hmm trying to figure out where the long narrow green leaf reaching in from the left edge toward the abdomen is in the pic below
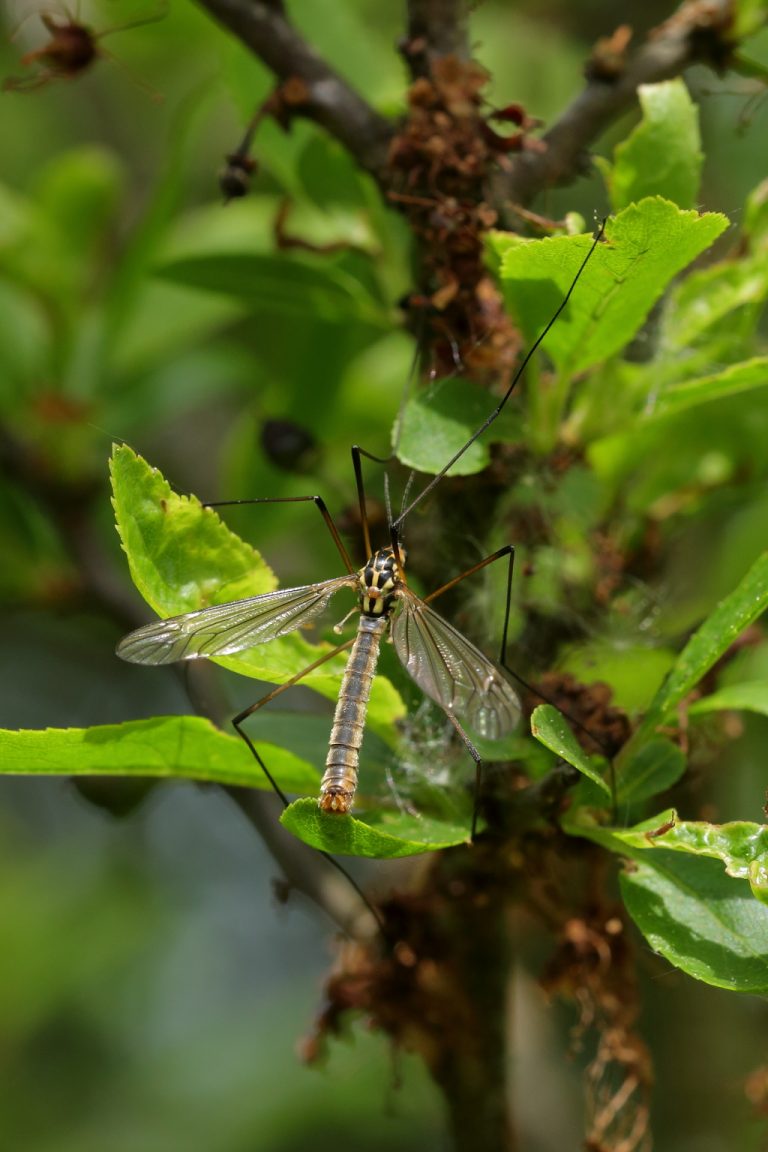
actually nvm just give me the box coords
[0,717,319,793]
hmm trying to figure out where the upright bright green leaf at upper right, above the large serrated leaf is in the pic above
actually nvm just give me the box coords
[608,79,704,210]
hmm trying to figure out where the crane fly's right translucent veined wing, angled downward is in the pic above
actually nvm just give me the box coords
[390,589,520,740]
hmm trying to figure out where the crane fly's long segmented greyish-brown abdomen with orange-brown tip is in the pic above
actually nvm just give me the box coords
[318,616,388,813]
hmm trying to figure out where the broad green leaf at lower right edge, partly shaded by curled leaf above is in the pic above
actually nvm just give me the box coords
[621,851,768,995]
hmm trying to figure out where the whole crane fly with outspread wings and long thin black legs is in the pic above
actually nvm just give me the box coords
[117,227,602,835]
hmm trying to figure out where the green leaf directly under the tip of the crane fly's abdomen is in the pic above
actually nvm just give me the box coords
[280,799,470,859]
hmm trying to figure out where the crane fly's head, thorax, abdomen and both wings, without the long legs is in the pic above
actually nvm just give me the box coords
[117,546,520,813]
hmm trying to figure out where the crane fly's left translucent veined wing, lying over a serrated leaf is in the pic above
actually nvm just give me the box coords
[117,576,357,664]
